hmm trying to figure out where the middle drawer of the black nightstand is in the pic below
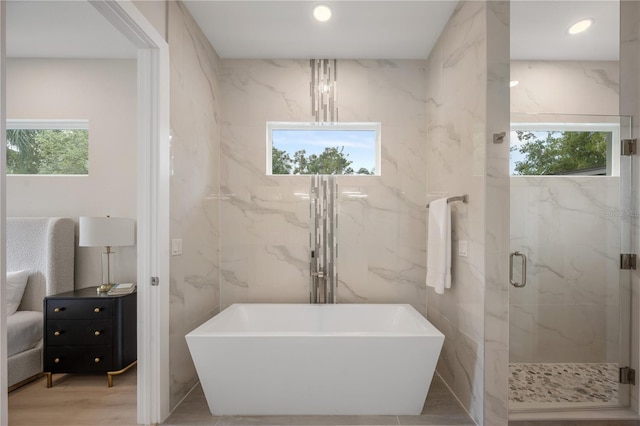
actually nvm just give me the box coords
[46,320,113,346]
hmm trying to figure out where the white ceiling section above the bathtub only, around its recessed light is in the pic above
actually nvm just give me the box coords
[185,0,457,59]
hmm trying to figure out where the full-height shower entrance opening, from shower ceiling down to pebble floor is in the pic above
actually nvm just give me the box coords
[509,2,633,414]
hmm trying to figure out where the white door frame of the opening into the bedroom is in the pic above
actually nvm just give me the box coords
[0,0,170,425]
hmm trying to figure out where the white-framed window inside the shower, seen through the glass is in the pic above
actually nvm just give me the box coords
[509,123,620,176]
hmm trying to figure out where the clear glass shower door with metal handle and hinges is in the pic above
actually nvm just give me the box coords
[509,114,636,411]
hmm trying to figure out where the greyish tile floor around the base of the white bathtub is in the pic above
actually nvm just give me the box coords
[163,376,475,426]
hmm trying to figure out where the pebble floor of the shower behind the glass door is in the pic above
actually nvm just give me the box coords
[509,363,618,404]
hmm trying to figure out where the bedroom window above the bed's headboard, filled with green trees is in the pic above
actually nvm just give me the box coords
[7,120,89,175]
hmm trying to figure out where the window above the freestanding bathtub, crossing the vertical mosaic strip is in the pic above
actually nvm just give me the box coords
[267,122,380,176]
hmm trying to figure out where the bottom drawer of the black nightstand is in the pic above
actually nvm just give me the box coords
[43,346,112,373]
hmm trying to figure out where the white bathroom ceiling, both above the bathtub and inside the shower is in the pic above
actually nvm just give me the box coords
[185,0,620,60]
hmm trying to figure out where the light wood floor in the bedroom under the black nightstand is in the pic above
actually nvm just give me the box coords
[9,367,137,426]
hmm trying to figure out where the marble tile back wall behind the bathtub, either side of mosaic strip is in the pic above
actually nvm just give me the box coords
[220,60,426,312]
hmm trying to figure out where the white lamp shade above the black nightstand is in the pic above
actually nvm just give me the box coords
[79,217,134,247]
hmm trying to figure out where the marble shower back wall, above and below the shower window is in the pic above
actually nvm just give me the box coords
[509,61,621,362]
